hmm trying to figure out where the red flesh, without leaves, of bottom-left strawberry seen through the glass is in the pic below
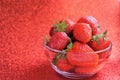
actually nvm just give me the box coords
[57,59,74,71]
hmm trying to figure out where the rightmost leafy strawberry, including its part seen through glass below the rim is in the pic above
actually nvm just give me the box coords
[88,32,110,59]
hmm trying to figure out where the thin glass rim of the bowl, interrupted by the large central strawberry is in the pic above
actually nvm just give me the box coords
[44,42,112,54]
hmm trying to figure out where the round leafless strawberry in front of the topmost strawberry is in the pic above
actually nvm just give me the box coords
[73,23,92,43]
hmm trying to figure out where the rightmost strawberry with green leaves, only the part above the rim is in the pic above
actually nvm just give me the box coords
[89,32,110,51]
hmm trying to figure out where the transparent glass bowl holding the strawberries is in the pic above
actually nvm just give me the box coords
[44,43,112,79]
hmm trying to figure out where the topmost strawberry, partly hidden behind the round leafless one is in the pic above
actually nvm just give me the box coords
[78,16,100,35]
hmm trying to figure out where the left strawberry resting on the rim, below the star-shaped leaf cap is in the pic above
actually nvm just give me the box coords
[47,32,69,50]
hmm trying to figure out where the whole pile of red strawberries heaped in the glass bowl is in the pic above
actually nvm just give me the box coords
[46,16,110,74]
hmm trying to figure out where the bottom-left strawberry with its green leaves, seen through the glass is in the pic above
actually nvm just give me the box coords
[53,53,74,71]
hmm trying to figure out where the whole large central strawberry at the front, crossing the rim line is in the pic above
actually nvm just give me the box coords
[67,42,98,67]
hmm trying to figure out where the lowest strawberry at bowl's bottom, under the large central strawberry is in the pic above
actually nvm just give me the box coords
[74,66,97,74]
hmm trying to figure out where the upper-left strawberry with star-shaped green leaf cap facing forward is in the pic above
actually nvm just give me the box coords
[49,19,75,36]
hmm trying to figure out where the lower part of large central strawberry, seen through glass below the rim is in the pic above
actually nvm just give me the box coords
[67,51,99,67]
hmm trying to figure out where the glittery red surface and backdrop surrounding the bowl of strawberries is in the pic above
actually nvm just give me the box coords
[0,0,120,80]
